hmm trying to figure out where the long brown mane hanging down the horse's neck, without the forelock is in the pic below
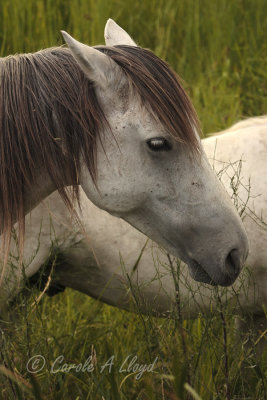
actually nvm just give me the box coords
[0,48,106,264]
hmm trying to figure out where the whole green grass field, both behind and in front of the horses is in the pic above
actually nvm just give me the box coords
[0,0,267,400]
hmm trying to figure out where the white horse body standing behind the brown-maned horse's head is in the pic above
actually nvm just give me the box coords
[2,116,267,334]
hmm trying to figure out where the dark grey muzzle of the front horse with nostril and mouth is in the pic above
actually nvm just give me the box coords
[172,196,248,286]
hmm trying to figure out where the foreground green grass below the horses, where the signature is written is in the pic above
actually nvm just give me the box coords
[0,268,267,400]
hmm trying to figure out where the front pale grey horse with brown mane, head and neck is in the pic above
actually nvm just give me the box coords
[0,21,248,286]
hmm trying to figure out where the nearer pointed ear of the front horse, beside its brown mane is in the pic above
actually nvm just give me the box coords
[61,31,121,88]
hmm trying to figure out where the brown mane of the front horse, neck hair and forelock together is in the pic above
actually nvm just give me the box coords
[0,46,199,266]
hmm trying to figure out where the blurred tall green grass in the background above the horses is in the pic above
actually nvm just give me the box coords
[0,0,267,132]
